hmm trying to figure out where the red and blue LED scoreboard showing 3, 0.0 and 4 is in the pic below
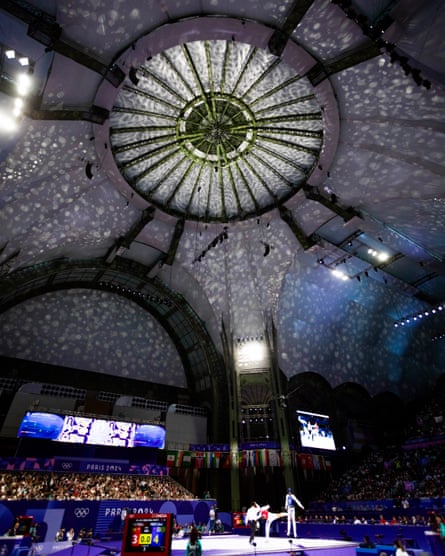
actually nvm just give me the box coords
[121,513,173,556]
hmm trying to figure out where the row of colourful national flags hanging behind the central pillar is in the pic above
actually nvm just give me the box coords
[167,449,331,471]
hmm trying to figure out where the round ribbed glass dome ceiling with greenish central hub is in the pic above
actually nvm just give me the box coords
[110,40,323,222]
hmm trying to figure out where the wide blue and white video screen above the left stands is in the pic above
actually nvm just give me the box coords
[17,411,165,449]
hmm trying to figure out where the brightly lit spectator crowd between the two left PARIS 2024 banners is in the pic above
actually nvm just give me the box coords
[0,471,195,500]
